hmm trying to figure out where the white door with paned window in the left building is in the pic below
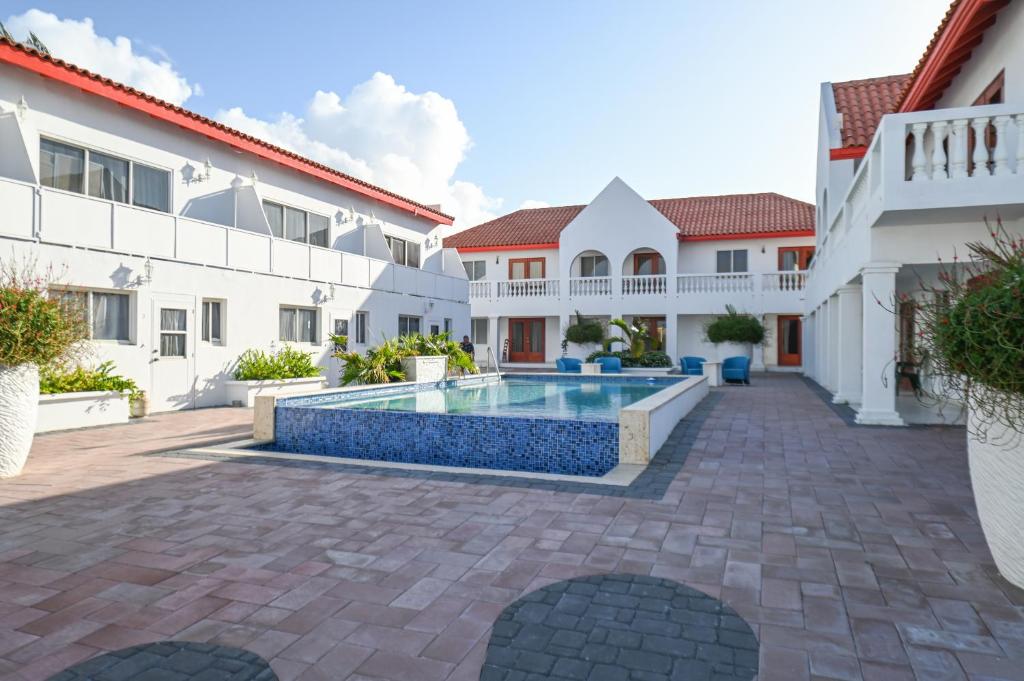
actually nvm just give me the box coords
[150,294,196,412]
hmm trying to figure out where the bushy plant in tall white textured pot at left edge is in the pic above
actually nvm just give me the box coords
[0,261,86,477]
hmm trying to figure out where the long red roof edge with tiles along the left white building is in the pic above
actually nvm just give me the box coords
[0,37,454,224]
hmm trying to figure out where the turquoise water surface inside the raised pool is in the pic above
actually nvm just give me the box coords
[315,378,667,422]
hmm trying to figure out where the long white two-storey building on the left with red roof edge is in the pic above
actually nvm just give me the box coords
[0,39,470,411]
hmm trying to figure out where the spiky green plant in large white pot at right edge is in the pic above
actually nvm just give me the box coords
[900,221,1024,588]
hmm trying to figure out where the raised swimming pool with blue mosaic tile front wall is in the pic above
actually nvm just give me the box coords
[255,374,707,476]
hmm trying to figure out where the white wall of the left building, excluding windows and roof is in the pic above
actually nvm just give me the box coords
[0,65,470,411]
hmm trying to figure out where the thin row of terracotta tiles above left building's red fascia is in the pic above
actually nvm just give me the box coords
[0,37,453,223]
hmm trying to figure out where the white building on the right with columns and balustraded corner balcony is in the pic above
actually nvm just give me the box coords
[804,0,1024,425]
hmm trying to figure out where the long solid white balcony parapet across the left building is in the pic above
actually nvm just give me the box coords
[0,178,469,302]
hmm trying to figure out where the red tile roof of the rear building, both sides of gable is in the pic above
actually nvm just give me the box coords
[444,193,814,249]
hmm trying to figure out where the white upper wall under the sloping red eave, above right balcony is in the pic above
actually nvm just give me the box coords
[935,2,1024,109]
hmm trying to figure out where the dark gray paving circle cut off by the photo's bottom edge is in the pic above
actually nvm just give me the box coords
[48,641,278,681]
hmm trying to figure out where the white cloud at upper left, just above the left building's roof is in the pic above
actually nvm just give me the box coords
[4,9,199,104]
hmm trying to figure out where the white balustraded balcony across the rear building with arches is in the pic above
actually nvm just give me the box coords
[469,271,807,314]
